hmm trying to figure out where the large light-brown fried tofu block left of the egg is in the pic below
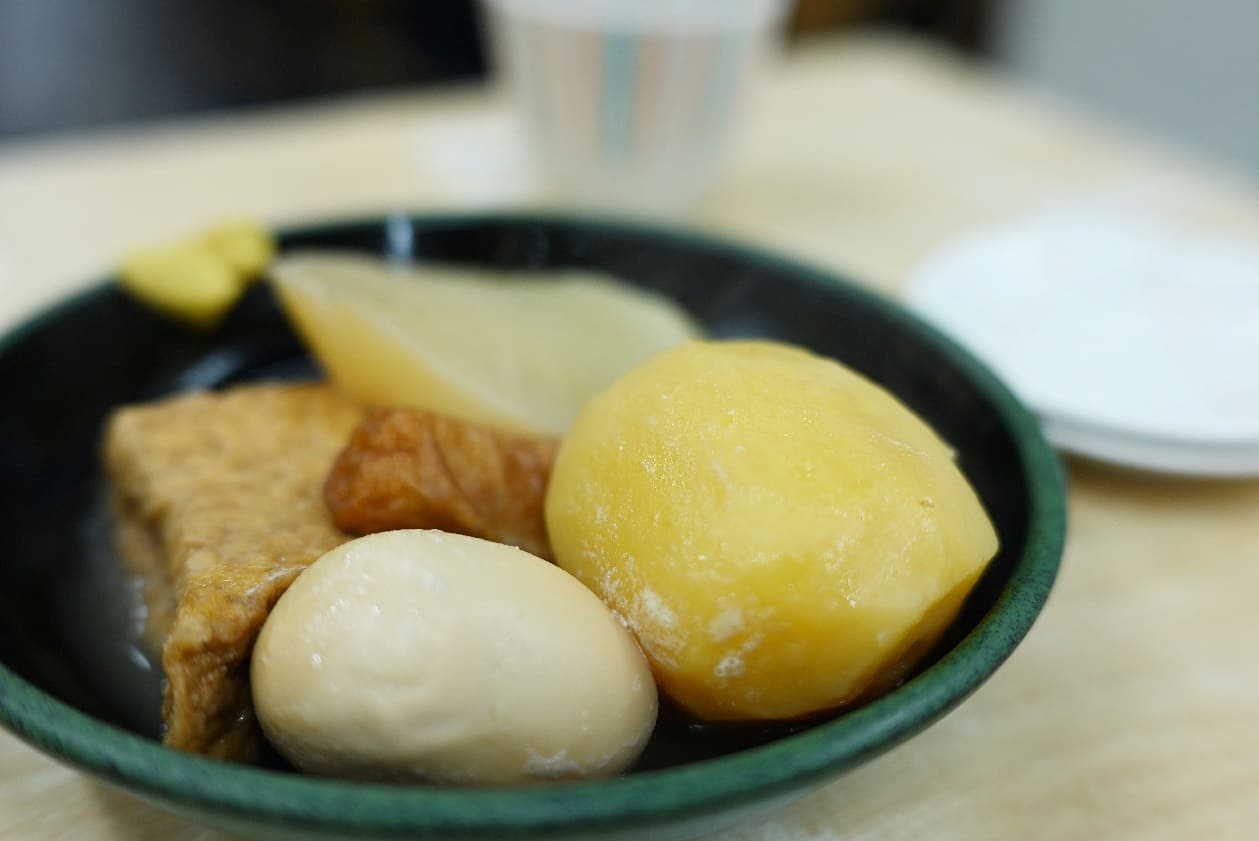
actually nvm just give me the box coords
[103,384,363,760]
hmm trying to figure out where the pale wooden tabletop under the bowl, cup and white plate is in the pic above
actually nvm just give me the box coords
[0,37,1259,841]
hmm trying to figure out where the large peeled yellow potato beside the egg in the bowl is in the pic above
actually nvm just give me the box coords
[546,341,997,720]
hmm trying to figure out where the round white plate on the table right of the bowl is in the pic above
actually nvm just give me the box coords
[905,205,1259,476]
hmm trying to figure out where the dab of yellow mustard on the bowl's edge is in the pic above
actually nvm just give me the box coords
[120,219,276,329]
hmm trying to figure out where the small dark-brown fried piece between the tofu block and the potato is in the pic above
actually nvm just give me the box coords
[324,408,559,559]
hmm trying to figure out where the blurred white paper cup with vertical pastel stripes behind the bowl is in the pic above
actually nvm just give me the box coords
[483,0,787,213]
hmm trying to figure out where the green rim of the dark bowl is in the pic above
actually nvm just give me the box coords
[0,212,1066,837]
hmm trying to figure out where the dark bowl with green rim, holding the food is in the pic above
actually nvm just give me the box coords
[0,215,1065,840]
